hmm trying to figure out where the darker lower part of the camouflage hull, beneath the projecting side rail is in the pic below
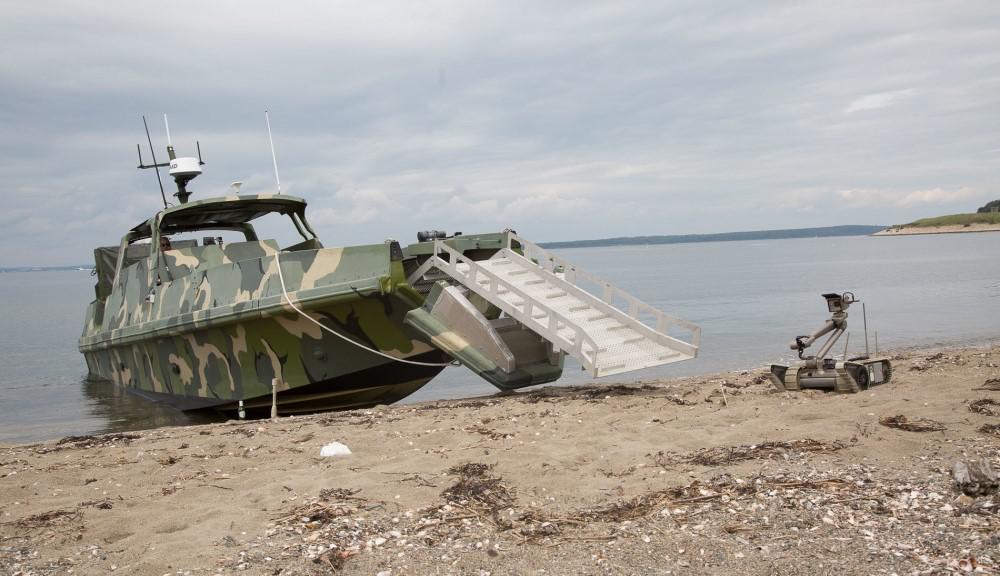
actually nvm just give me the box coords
[84,297,449,414]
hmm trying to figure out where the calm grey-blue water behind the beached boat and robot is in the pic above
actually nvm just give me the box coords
[0,233,1000,442]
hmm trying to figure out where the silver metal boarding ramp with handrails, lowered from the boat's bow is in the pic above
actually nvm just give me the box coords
[409,232,701,377]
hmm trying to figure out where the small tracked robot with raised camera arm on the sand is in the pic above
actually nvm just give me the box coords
[770,292,892,393]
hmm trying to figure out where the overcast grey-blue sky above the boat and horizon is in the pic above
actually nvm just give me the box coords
[0,0,1000,266]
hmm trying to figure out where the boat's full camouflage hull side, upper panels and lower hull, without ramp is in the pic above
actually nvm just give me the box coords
[80,243,450,414]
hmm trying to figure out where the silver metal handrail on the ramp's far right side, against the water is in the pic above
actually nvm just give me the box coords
[508,231,701,351]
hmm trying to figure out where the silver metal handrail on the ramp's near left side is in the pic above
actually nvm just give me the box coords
[410,240,599,370]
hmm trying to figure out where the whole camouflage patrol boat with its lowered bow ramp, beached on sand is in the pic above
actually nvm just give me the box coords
[79,125,700,415]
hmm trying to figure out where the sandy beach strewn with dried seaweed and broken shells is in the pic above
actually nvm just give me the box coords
[0,347,1000,576]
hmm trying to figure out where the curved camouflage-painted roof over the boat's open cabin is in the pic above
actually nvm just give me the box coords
[132,194,306,237]
